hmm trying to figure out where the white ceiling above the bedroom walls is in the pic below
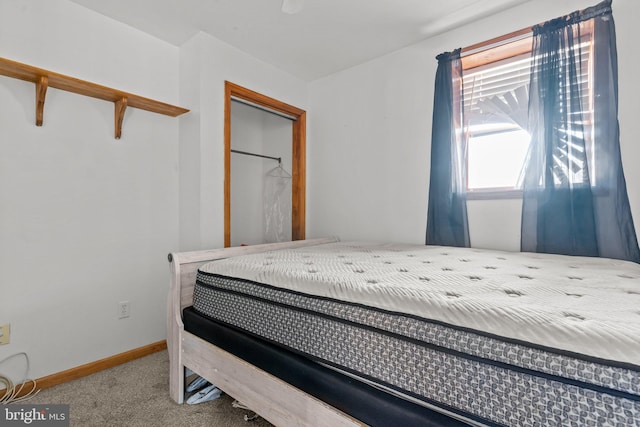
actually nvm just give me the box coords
[71,0,530,81]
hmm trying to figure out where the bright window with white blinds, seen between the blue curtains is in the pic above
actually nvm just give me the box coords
[462,29,593,198]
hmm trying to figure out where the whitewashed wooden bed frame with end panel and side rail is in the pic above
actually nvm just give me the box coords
[167,238,364,427]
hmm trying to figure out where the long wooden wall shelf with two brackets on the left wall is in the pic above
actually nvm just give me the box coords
[0,57,189,139]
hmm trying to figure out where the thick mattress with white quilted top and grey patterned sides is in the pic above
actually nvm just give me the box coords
[194,242,640,426]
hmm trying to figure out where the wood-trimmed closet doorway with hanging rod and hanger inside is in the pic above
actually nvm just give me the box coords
[224,82,306,247]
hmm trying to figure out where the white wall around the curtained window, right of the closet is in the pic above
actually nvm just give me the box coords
[308,0,640,250]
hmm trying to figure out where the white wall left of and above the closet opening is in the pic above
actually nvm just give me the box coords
[180,33,307,250]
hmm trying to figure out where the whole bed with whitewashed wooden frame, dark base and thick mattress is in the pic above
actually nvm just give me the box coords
[168,238,640,426]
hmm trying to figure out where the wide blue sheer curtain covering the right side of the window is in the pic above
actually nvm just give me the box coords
[521,0,640,262]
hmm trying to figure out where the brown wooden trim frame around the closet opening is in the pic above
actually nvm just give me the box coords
[224,81,307,247]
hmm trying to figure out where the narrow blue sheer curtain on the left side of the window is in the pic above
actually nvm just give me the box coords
[426,49,469,247]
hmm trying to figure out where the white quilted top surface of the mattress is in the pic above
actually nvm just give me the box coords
[200,242,640,366]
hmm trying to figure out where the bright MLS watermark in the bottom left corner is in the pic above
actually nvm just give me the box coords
[0,405,69,427]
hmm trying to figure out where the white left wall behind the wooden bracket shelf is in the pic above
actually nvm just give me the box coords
[0,0,179,379]
